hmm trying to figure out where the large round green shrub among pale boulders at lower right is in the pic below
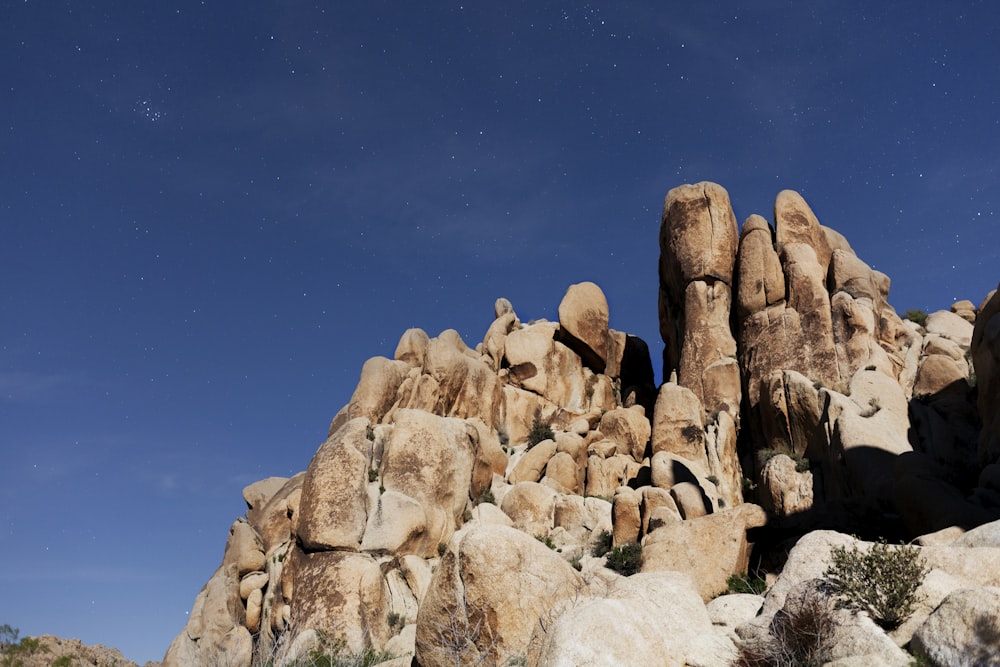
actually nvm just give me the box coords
[823,539,929,630]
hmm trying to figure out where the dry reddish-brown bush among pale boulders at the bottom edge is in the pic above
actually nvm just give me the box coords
[735,587,835,667]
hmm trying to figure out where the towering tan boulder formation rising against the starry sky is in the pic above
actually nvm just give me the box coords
[164,183,1000,667]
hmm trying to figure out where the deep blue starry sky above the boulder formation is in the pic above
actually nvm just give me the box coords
[0,0,1000,662]
